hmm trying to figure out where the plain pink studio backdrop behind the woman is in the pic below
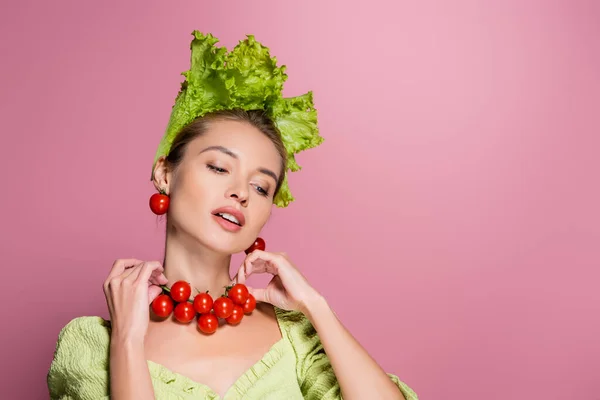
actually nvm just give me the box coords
[0,0,600,400]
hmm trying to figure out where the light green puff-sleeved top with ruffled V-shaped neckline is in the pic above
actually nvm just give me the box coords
[47,308,418,400]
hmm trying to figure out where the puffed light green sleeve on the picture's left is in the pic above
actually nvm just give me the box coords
[46,317,110,399]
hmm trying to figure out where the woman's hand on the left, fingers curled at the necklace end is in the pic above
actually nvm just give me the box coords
[104,259,167,340]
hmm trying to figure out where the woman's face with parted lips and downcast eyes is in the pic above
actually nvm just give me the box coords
[158,120,281,254]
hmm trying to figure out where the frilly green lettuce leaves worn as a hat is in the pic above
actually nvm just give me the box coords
[152,31,324,207]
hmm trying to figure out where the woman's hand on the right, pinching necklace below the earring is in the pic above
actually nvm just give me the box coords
[234,250,321,313]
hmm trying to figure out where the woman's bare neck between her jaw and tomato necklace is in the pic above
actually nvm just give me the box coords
[163,225,231,298]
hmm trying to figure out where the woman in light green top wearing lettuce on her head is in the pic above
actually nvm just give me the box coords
[48,32,417,400]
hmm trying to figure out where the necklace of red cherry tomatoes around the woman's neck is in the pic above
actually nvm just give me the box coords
[152,281,256,334]
